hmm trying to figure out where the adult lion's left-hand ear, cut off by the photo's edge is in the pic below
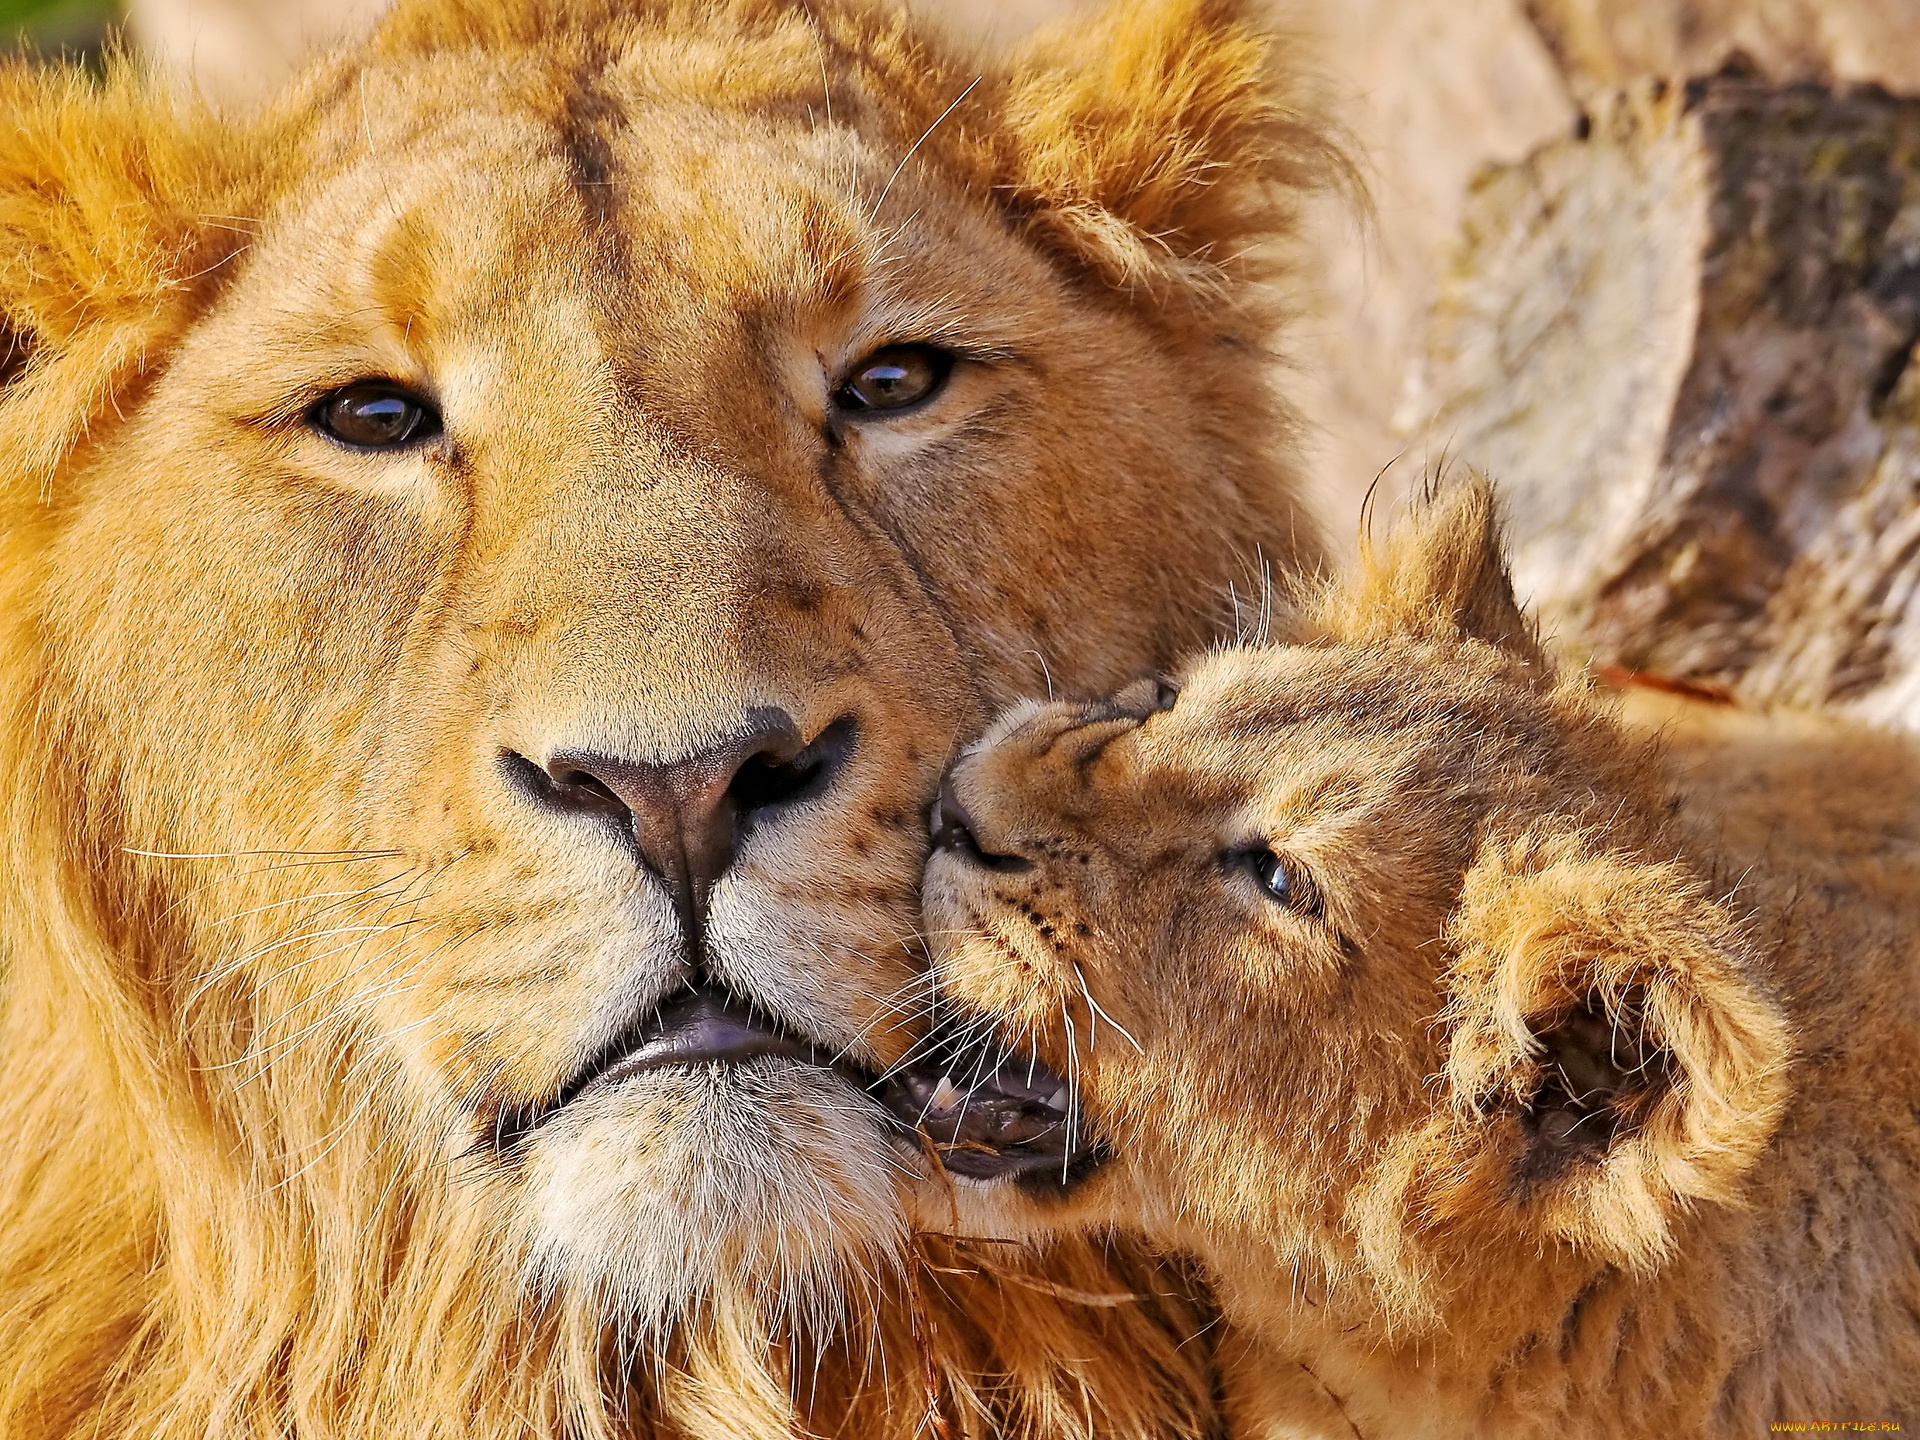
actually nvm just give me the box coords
[0,61,252,490]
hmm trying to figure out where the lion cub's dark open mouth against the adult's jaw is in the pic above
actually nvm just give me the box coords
[874,1023,1110,1192]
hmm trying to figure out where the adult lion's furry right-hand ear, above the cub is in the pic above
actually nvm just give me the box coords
[1002,0,1352,295]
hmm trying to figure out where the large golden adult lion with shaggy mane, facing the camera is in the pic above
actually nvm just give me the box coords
[0,0,1336,1440]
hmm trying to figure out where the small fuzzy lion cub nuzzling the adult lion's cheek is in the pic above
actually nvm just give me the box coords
[910,486,1920,1440]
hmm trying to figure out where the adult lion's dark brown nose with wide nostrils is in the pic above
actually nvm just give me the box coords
[509,708,854,935]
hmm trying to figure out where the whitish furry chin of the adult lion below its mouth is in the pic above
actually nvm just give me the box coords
[526,1060,906,1346]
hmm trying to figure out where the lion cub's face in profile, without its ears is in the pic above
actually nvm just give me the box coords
[924,639,1582,1238]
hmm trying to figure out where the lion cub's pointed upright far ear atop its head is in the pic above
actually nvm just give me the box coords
[1313,474,1548,668]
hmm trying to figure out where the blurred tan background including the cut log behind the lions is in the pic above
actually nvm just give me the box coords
[11,0,1920,726]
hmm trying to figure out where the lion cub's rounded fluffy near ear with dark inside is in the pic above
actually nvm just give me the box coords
[1425,851,1791,1265]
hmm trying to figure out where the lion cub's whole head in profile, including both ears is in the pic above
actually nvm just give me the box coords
[921,499,1788,1315]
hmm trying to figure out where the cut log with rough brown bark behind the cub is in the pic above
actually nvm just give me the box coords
[1402,75,1920,726]
